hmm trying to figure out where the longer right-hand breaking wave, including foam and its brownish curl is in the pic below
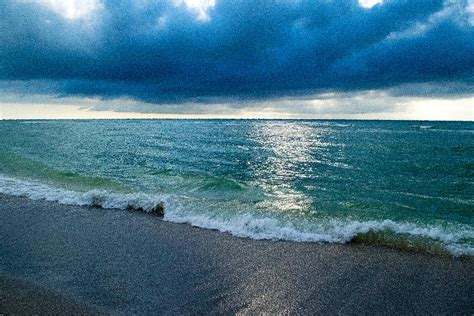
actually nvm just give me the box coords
[165,212,474,256]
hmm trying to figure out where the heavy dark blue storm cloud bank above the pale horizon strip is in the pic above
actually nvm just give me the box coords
[0,0,474,103]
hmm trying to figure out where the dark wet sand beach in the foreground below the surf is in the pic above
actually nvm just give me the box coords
[0,195,474,314]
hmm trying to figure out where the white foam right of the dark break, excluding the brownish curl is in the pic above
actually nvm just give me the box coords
[165,211,474,256]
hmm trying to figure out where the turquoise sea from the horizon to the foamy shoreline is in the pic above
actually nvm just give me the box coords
[0,120,474,255]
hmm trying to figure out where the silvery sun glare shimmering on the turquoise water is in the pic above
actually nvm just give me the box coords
[248,121,326,214]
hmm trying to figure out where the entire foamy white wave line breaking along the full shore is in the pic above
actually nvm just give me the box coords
[0,175,474,256]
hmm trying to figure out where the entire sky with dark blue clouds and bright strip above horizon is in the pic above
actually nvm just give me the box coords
[0,0,474,121]
